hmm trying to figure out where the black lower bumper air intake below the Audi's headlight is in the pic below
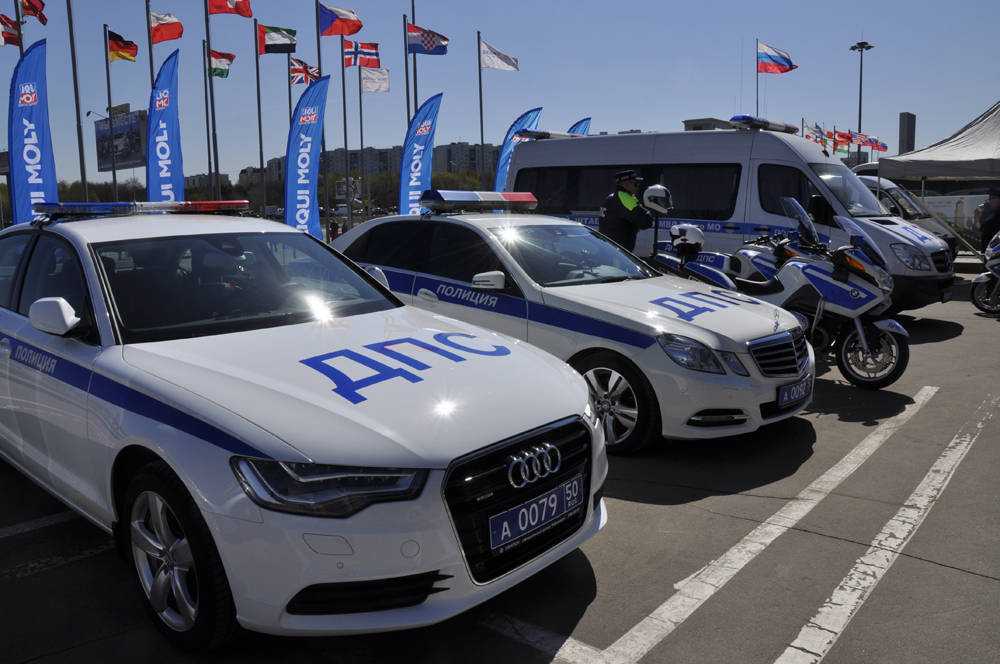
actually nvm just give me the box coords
[287,572,451,616]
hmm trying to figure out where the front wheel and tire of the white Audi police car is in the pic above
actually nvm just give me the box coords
[119,461,237,651]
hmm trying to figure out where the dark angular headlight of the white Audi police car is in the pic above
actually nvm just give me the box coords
[231,457,427,518]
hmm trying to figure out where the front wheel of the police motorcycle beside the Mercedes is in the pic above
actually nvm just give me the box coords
[835,328,910,390]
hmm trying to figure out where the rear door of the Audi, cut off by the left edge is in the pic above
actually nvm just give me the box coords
[0,231,36,463]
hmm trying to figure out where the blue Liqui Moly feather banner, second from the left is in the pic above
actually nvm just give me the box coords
[146,50,184,201]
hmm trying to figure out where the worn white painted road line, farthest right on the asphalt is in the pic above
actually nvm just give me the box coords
[775,397,1000,664]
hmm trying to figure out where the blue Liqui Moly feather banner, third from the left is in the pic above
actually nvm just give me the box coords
[285,76,330,239]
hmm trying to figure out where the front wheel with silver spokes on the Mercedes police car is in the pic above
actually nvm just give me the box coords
[571,351,660,455]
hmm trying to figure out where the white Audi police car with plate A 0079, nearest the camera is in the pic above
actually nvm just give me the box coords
[0,203,607,647]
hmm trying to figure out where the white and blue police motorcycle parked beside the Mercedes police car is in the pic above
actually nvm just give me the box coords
[645,187,910,390]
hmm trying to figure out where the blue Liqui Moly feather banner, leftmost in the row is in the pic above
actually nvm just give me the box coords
[7,39,59,224]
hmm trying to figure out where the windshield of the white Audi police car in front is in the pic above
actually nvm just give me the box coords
[94,233,399,343]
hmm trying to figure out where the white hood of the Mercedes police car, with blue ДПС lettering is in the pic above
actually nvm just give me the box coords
[544,276,798,352]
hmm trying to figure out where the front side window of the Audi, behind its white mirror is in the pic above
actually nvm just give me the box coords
[17,235,90,319]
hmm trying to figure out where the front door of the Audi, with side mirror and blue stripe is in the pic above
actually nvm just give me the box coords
[9,233,105,511]
